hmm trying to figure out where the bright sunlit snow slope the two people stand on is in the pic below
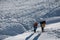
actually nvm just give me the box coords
[4,22,60,40]
